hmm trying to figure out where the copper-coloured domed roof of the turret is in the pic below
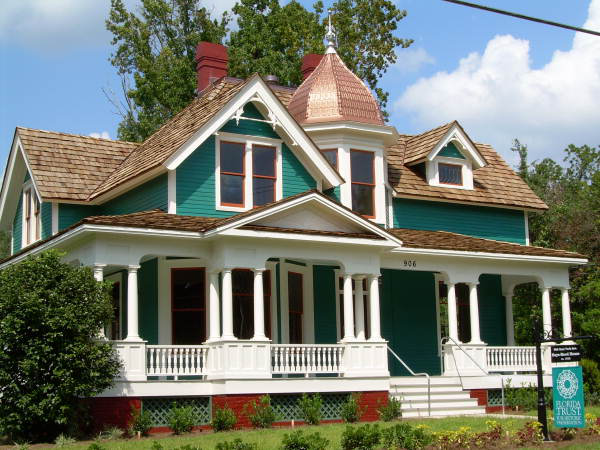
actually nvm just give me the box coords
[288,53,384,125]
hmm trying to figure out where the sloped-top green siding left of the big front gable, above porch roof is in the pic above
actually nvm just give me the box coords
[100,174,168,215]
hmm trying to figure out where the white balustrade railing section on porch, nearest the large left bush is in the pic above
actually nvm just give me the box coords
[146,345,208,379]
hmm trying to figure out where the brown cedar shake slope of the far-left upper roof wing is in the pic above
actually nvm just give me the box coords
[16,127,138,200]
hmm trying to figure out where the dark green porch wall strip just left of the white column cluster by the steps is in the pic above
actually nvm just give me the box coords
[313,266,337,344]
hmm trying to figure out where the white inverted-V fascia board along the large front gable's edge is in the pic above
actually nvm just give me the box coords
[163,76,344,187]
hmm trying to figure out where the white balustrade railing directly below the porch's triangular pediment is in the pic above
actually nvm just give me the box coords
[271,344,344,375]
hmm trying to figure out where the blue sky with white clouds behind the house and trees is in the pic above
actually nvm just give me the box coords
[0,0,600,172]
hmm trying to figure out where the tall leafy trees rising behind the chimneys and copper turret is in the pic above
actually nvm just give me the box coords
[106,0,412,141]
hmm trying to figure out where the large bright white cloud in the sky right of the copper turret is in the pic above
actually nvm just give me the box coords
[394,0,600,162]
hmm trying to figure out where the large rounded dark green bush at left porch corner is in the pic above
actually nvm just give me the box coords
[0,251,120,441]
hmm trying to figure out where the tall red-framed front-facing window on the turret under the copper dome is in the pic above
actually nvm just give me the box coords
[350,150,375,218]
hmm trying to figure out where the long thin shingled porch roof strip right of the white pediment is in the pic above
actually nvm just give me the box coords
[389,228,585,259]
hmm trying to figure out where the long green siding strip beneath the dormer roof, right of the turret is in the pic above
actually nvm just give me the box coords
[394,199,526,244]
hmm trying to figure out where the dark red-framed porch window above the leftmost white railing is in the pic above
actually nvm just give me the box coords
[171,267,206,345]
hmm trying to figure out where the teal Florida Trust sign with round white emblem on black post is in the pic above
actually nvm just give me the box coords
[552,366,585,428]
